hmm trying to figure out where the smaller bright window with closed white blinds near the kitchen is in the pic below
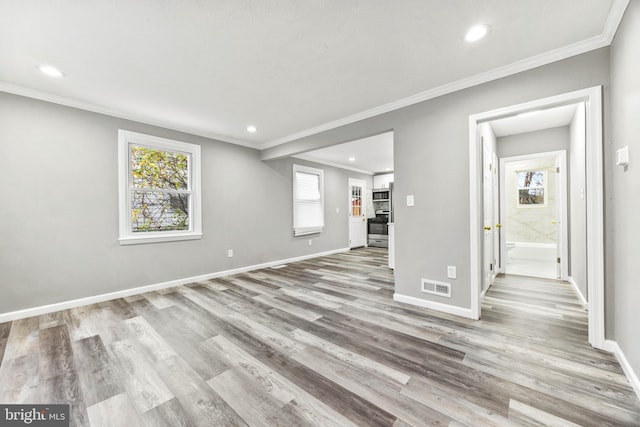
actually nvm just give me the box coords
[293,165,324,236]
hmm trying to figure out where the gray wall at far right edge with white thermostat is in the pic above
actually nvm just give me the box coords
[605,1,640,388]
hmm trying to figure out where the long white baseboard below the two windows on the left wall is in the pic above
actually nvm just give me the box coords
[0,248,349,323]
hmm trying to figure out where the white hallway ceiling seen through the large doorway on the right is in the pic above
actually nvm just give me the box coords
[490,104,577,138]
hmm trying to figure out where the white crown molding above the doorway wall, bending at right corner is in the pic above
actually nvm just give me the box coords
[260,0,630,150]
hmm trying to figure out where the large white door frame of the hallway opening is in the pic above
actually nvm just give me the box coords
[469,86,606,350]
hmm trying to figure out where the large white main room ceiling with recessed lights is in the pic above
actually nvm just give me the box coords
[0,0,628,148]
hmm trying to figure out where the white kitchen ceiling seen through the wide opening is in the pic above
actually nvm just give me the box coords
[294,132,393,175]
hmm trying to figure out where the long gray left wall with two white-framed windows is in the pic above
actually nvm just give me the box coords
[0,92,373,313]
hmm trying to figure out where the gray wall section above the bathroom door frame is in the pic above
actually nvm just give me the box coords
[498,126,570,159]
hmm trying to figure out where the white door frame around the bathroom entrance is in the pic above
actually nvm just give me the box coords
[499,150,569,280]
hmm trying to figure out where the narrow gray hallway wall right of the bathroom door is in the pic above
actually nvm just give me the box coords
[569,103,589,299]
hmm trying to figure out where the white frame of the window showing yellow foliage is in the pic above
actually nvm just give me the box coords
[118,129,202,245]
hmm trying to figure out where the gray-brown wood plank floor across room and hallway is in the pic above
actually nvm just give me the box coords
[0,248,640,427]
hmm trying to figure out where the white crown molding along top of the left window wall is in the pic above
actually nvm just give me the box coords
[0,82,261,150]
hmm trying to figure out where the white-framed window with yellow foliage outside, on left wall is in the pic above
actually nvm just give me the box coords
[118,130,202,245]
